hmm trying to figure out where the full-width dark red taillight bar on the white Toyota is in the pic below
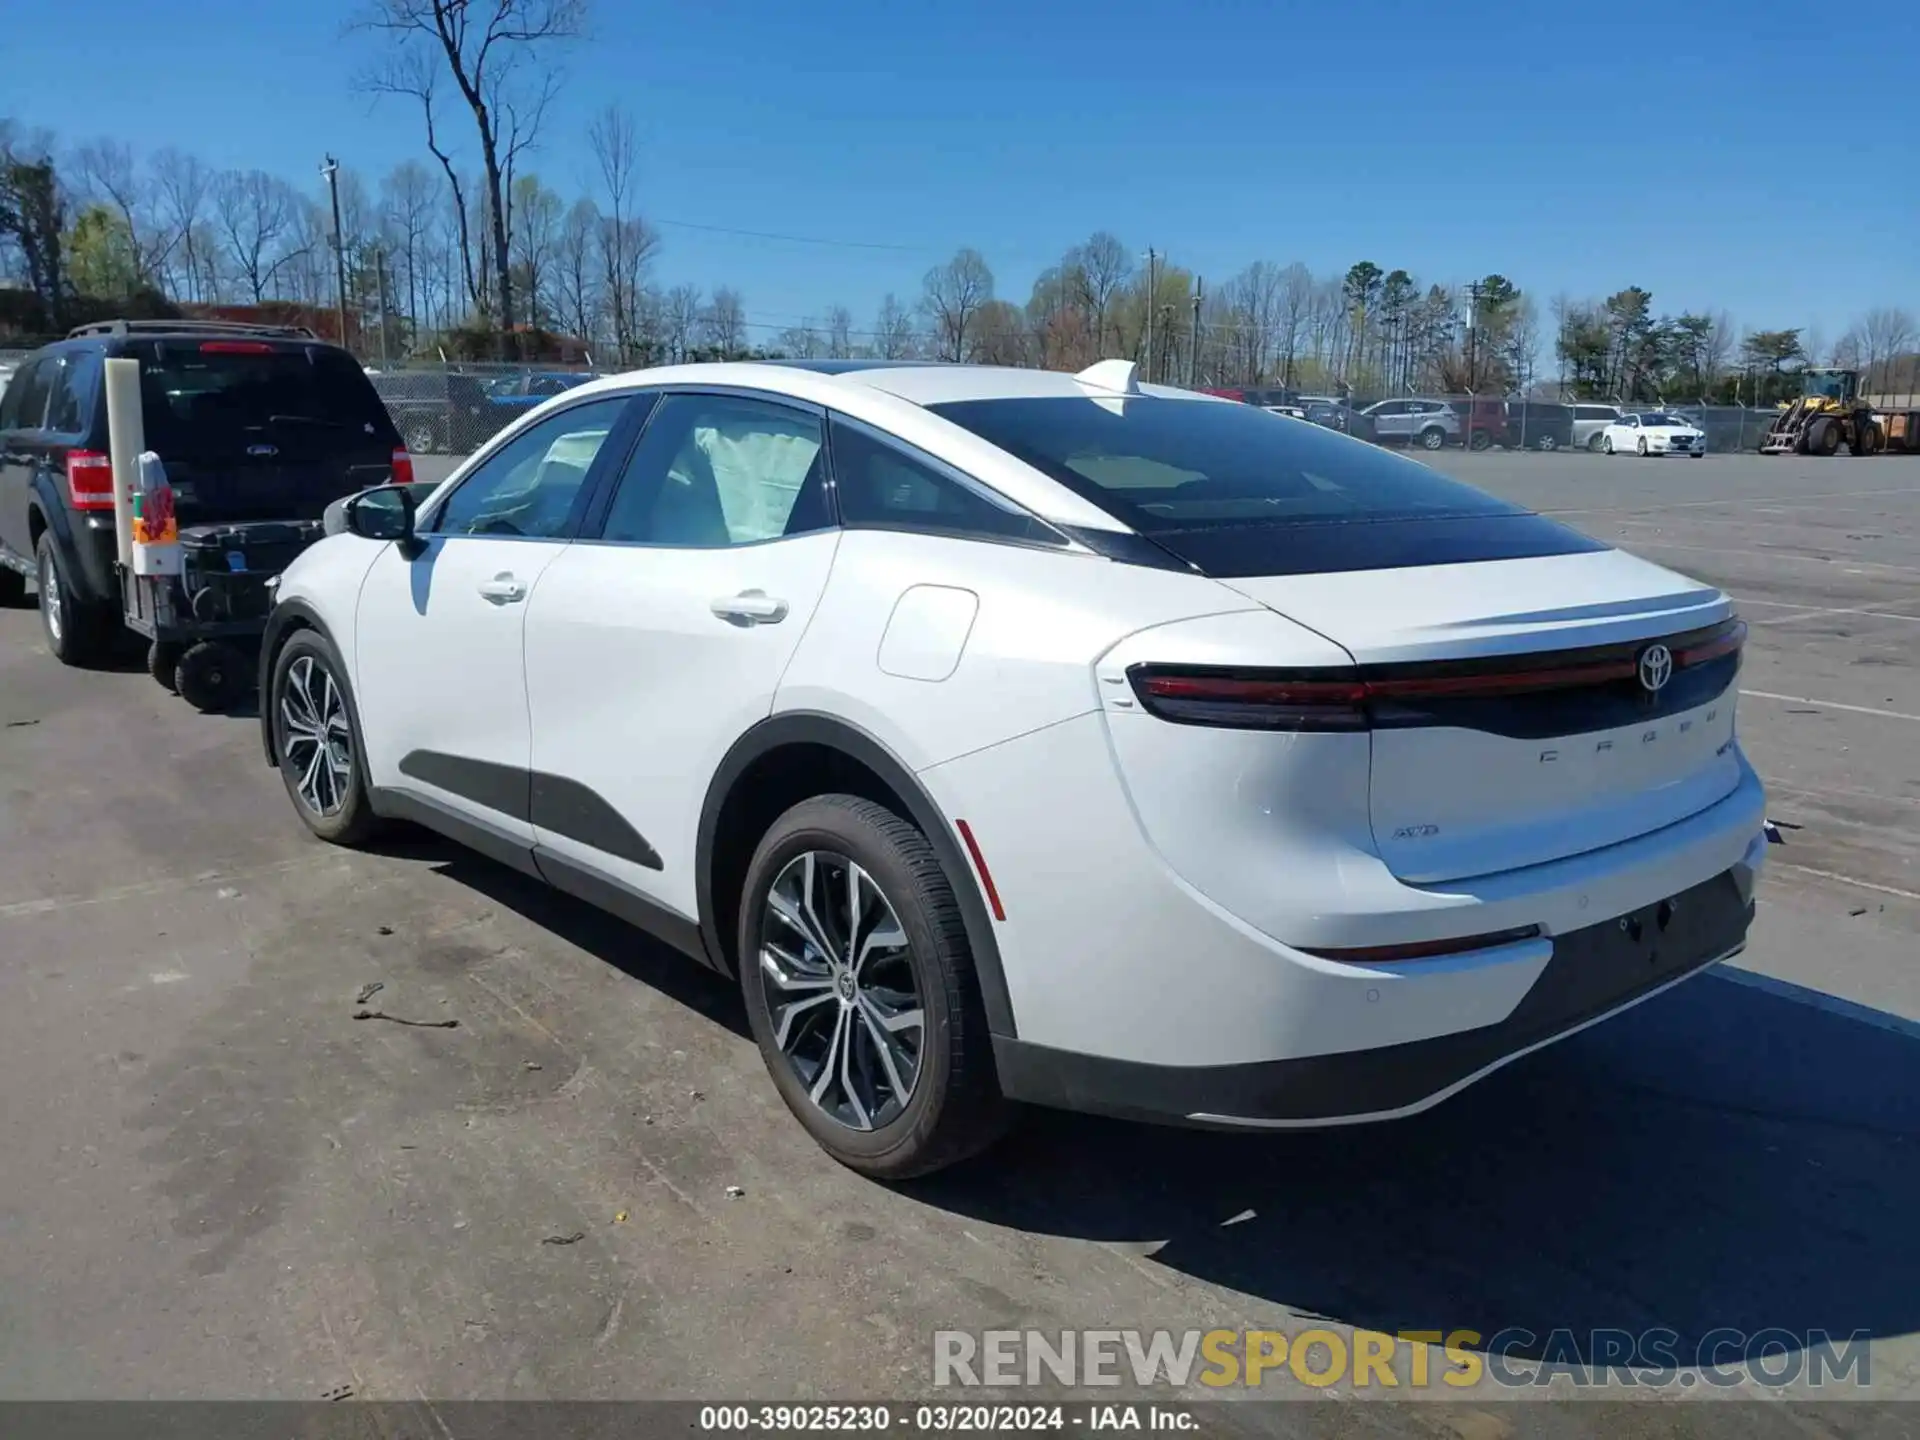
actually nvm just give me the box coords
[1127,620,1747,730]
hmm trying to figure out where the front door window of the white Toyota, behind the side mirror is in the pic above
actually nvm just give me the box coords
[424,396,628,540]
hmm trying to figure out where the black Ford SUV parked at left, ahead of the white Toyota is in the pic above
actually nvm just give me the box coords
[0,321,413,664]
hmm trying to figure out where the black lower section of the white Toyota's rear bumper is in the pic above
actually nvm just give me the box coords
[995,856,1764,1129]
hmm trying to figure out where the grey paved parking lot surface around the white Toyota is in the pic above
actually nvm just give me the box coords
[0,453,1920,1436]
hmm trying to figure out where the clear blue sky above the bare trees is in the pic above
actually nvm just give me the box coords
[0,0,1920,342]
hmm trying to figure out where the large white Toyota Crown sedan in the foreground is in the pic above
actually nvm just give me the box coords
[261,361,1764,1175]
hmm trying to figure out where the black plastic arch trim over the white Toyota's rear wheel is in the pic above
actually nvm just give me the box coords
[695,712,1016,1037]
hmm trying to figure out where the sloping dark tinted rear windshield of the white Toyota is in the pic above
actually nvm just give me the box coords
[931,396,1605,576]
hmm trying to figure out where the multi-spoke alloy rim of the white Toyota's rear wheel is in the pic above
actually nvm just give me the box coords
[760,851,925,1131]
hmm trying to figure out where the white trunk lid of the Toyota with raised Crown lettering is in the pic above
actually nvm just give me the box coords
[1221,551,1740,883]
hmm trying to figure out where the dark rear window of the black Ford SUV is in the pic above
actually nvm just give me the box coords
[138,340,396,453]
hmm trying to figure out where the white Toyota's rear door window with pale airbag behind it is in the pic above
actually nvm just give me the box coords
[601,396,831,549]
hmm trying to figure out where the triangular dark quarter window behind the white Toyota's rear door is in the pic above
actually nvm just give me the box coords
[833,419,1066,545]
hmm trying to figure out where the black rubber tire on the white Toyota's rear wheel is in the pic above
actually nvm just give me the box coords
[739,795,1012,1181]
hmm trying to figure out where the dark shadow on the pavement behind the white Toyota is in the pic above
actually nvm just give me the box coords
[912,975,1920,1365]
